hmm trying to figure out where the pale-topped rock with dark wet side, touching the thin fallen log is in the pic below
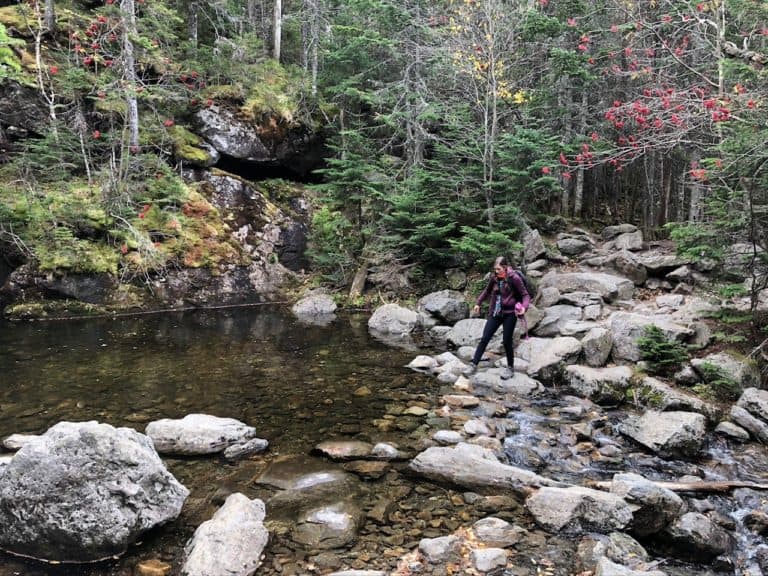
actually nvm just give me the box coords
[611,474,683,536]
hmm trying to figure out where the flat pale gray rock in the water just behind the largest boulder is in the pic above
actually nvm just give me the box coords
[145,414,256,455]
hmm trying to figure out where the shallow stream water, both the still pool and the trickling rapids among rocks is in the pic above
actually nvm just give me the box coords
[0,306,766,576]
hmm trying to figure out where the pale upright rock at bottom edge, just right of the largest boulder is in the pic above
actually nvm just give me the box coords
[181,493,269,576]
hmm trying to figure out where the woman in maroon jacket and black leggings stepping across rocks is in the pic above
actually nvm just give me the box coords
[469,256,531,379]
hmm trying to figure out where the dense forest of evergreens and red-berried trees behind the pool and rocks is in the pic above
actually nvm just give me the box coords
[0,0,768,302]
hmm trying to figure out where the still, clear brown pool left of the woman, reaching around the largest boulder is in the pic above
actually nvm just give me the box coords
[0,306,437,576]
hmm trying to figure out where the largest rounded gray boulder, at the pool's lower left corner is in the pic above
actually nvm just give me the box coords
[0,422,189,562]
